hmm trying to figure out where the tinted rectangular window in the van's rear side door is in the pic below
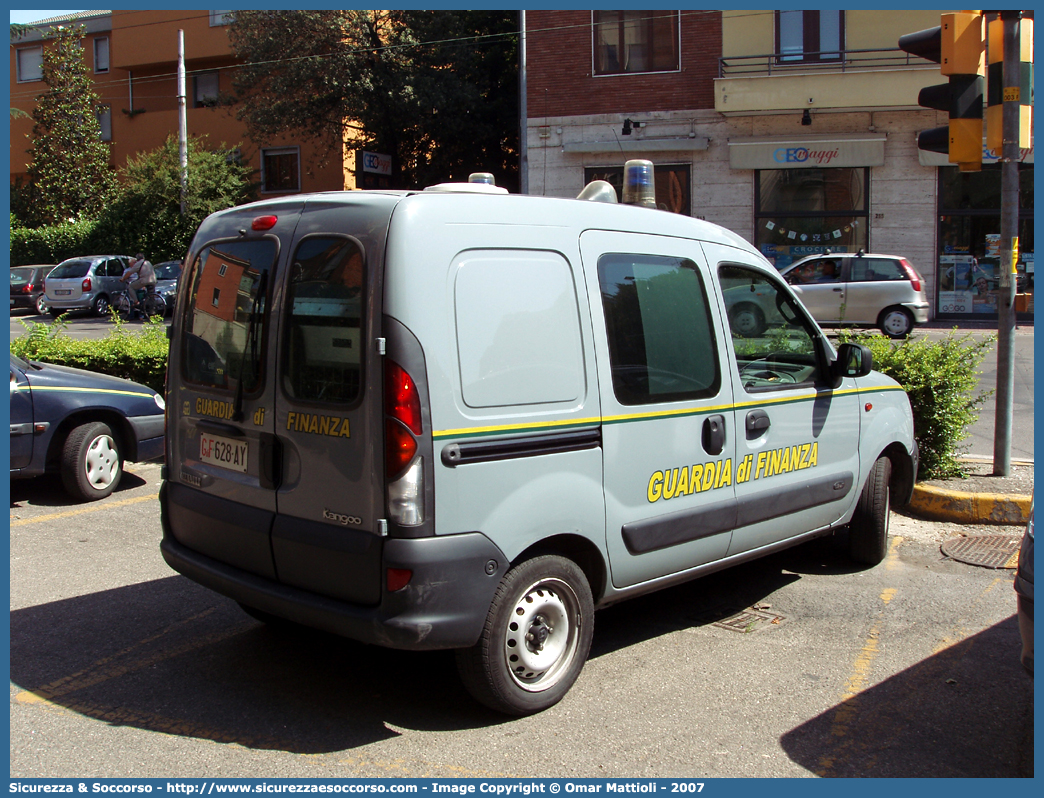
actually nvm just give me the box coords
[598,253,721,404]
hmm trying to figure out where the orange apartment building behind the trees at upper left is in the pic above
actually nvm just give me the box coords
[10,9,356,197]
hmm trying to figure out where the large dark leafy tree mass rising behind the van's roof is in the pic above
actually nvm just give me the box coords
[229,10,519,189]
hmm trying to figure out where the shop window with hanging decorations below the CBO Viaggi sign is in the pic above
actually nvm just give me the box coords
[755,167,870,268]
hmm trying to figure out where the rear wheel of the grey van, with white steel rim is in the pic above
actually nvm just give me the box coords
[457,555,594,715]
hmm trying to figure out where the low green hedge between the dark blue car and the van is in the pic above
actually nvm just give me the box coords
[10,313,169,394]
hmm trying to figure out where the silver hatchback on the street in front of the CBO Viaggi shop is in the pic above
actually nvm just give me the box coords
[781,252,928,338]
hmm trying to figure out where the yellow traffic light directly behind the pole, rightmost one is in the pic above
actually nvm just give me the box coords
[986,17,1034,156]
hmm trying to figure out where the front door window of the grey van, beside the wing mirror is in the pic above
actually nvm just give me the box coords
[718,264,816,393]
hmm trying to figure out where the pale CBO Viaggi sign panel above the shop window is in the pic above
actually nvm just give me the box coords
[729,136,884,169]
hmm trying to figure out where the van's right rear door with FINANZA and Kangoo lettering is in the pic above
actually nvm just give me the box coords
[265,195,393,605]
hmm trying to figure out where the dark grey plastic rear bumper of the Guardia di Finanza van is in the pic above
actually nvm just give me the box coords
[160,495,508,651]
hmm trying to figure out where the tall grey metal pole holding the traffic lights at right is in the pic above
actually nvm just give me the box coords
[993,11,1022,476]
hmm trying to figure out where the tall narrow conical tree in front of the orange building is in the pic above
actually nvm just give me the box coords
[27,25,116,225]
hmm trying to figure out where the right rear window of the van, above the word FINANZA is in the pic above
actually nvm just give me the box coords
[282,235,363,403]
